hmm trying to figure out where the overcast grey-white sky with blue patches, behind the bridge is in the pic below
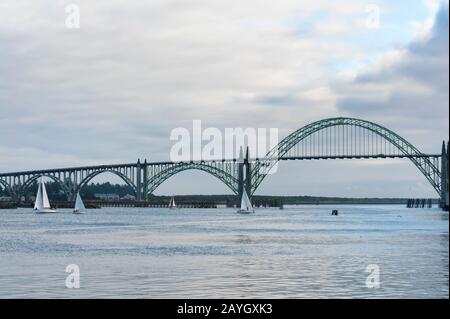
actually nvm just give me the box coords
[0,0,449,197]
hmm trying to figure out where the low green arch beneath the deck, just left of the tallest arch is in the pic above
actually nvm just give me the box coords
[146,162,238,195]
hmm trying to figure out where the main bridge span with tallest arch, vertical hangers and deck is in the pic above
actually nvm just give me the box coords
[251,117,442,195]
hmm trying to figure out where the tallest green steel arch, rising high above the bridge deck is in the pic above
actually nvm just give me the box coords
[251,117,441,195]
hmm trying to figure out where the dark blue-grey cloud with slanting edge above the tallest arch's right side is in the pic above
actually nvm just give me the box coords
[335,5,449,149]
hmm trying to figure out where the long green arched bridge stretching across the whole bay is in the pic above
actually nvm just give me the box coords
[0,117,449,208]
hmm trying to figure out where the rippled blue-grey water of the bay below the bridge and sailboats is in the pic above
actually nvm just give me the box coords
[0,206,449,298]
